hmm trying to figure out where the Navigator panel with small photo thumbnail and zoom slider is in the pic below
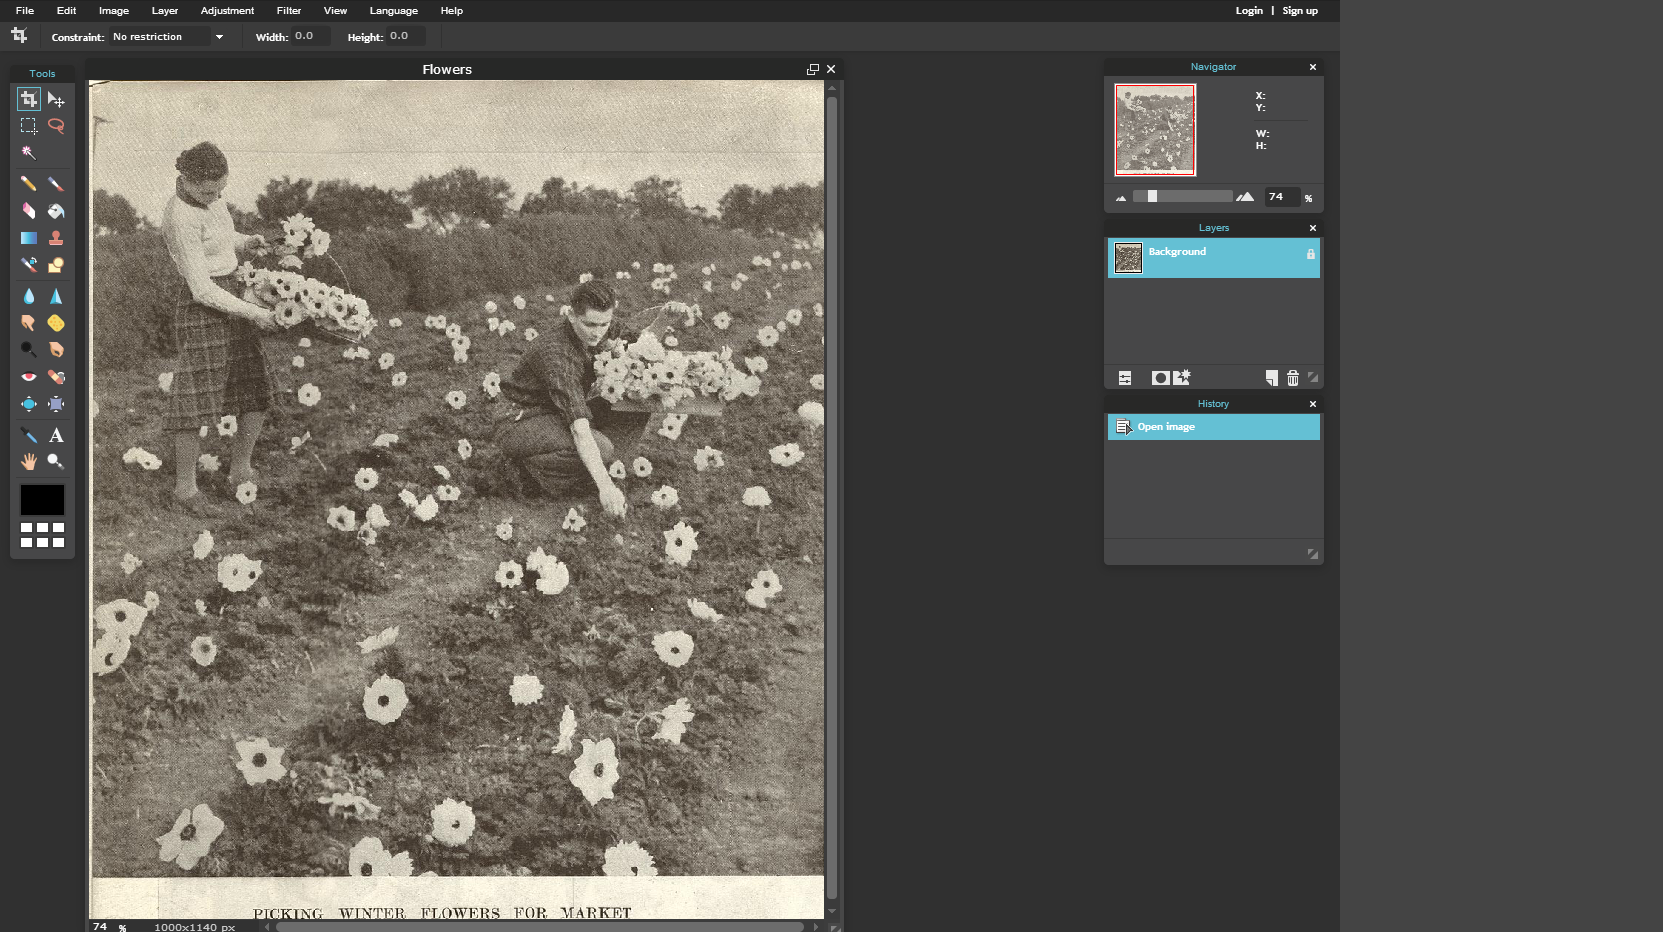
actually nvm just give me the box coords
[1103,57,1325,213]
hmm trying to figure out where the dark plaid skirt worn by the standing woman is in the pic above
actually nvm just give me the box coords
[165,276,278,431]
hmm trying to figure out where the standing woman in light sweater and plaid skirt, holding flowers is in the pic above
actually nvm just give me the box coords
[161,141,278,514]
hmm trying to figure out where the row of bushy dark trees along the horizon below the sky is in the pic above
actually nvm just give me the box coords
[93,168,825,236]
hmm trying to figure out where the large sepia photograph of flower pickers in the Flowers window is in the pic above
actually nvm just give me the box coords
[88,80,824,919]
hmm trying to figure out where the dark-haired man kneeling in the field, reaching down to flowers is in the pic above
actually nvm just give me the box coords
[496,281,649,516]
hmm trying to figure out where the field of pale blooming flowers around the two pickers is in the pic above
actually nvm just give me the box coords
[90,236,825,877]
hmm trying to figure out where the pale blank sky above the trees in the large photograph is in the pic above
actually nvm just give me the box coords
[90,82,825,221]
